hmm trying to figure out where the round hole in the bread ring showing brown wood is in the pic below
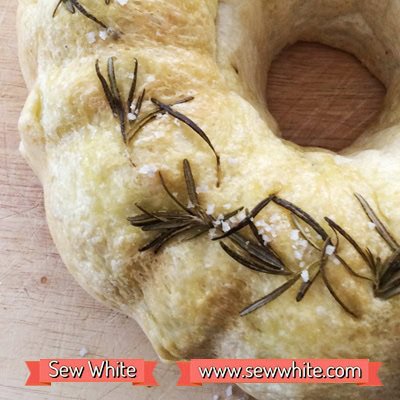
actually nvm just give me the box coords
[267,42,386,151]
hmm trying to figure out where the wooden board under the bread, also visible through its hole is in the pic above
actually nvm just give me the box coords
[0,0,384,400]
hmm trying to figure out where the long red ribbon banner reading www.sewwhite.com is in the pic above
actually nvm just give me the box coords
[177,359,382,386]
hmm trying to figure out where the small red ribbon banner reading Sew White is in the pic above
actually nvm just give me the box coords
[25,359,158,386]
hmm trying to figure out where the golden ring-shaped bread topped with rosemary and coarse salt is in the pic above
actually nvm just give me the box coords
[18,0,400,400]
